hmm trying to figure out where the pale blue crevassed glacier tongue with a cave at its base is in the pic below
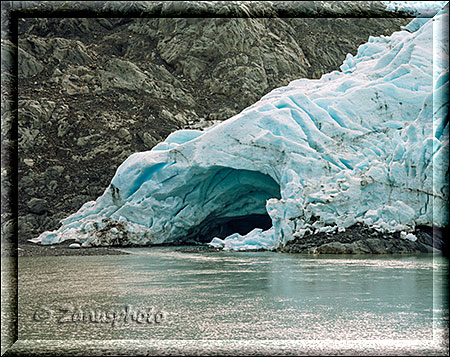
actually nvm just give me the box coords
[32,6,448,249]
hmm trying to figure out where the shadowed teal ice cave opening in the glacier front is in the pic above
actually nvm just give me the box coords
[173,167,281,245]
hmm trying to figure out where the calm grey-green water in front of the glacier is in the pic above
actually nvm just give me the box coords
[7,248,448,354]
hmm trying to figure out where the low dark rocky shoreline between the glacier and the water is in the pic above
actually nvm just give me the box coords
[11,224,448,257]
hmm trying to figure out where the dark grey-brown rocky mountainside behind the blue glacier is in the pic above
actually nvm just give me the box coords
[2,2,408,240]
